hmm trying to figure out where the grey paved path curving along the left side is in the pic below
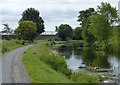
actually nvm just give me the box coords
[0,45,34,83]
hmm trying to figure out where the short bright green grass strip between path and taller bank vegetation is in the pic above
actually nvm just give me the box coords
[23,49,73,83]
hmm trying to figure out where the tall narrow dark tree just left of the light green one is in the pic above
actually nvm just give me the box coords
[78,8,95,46]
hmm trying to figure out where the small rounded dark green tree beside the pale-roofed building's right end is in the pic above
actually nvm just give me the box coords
[58,24,73,40]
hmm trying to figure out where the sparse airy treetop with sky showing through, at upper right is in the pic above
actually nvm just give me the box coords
[97,2,117,24]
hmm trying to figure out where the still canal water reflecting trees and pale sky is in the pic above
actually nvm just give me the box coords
[53,43,120,74]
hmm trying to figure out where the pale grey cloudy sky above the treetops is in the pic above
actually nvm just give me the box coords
[0,0,120,31]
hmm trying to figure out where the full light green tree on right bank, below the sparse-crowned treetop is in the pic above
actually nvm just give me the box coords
[90,14,111,48]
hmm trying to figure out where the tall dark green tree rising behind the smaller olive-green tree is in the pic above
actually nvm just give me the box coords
[20,8,45,34]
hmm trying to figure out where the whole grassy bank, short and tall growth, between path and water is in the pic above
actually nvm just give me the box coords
[23,42,100,83]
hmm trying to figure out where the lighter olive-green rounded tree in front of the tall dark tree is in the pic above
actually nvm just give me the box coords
[14,21,36,41]
